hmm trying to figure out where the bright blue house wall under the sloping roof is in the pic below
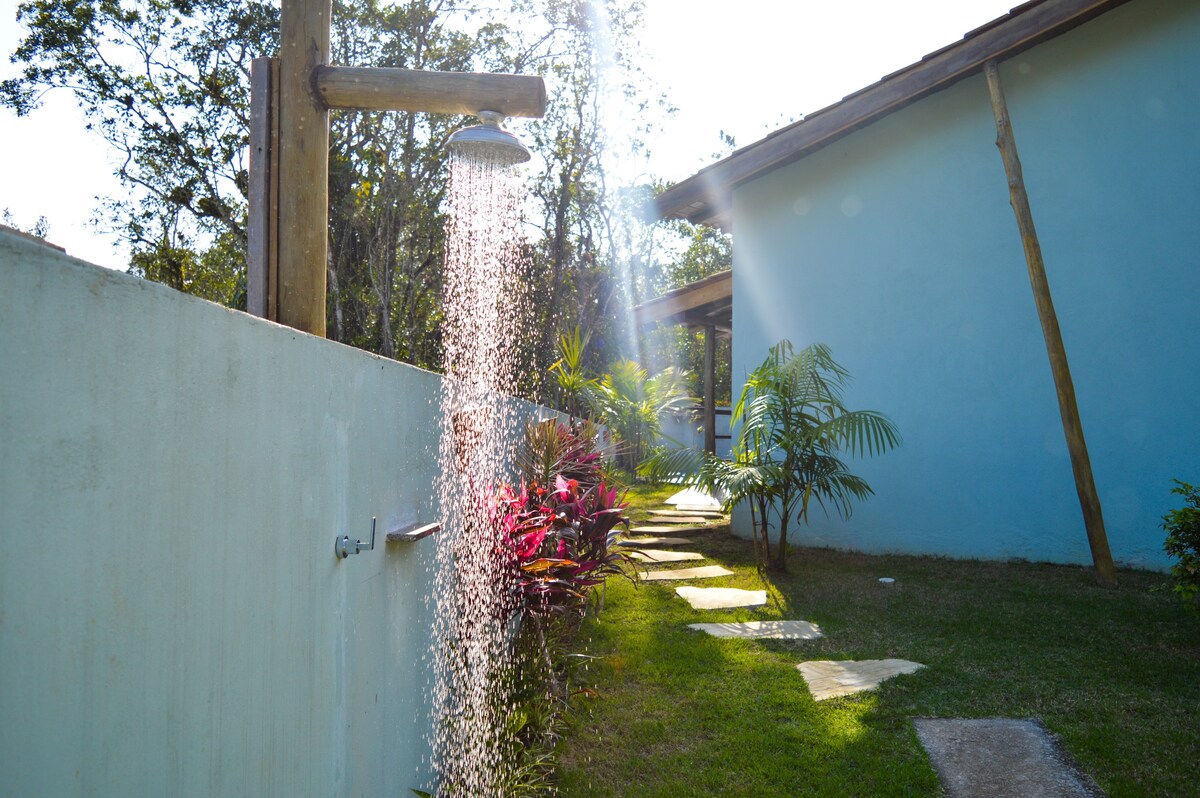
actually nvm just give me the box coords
[733,0,1200,568]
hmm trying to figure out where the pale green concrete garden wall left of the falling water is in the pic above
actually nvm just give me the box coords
[0,234,540,797]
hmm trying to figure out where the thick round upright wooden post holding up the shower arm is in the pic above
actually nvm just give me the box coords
[277,0,331,337]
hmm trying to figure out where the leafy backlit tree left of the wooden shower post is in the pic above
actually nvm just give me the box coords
[0,0,278,304]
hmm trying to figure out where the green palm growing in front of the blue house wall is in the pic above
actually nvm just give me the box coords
[643,340,900,570]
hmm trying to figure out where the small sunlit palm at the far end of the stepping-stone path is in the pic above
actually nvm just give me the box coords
[588,360,694,474]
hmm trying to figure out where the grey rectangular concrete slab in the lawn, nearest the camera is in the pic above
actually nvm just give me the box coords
[912,718,1104,798]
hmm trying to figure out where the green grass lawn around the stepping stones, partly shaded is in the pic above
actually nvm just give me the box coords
[559,488,1200,798]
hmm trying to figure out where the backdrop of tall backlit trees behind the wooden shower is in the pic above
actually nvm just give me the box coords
[7,0,667,395]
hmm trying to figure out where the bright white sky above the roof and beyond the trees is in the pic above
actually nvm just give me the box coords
[0,0,1016,269]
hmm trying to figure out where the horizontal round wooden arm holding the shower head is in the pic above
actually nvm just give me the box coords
[314,66,546,116]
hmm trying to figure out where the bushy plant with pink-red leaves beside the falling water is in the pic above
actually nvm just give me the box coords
[493,475,629,617]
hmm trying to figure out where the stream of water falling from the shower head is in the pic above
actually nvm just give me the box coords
[430,147,528,798]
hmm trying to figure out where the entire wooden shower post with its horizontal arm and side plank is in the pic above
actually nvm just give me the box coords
[246,0,546,336]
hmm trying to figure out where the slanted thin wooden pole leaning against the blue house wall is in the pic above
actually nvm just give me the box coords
[984,61,1117,587]
